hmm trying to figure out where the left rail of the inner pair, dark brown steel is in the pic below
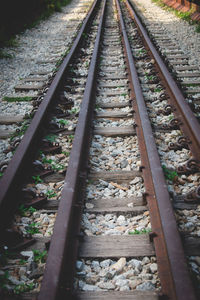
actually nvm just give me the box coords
[38,0,106,300]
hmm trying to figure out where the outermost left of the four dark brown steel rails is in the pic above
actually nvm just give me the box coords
[0,0,100,232]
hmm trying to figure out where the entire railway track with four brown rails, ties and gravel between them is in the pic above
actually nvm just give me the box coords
[0,1,199,300]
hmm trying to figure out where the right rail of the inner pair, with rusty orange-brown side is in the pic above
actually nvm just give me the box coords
[116,0,196,300]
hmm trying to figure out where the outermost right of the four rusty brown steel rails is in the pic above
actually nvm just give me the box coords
[125,0,200,159]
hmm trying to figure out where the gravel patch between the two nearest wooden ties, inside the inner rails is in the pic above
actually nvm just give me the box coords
[74,257,160,291]
